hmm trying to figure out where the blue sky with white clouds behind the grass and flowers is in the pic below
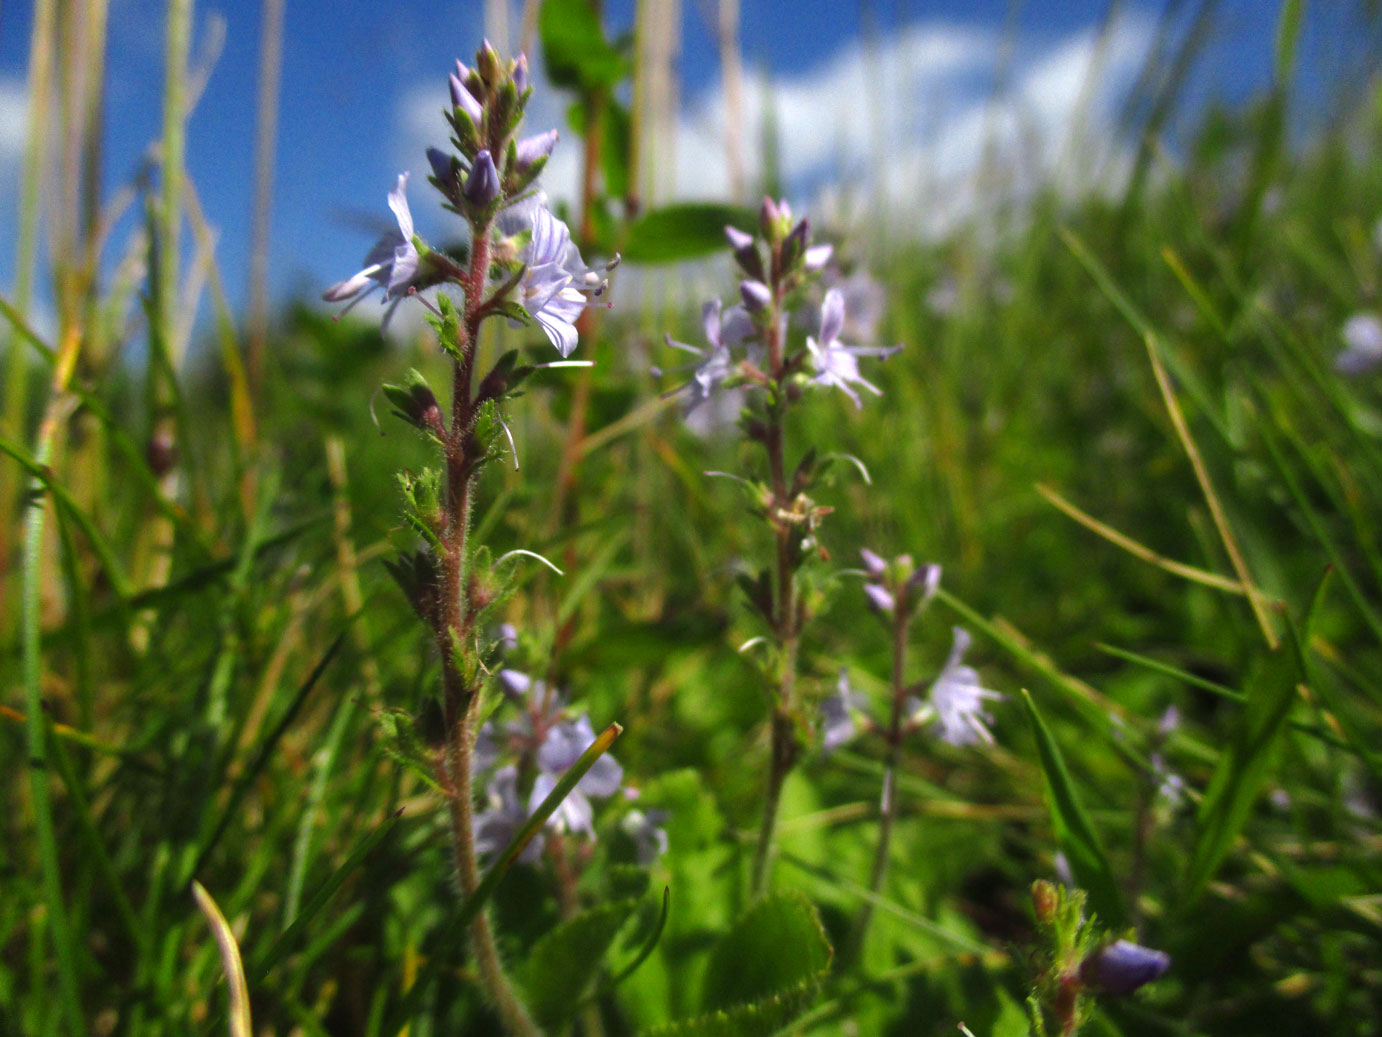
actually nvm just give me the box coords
[0,0,1363,334]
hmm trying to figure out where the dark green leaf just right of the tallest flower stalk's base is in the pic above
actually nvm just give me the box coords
[522,900,638,1029]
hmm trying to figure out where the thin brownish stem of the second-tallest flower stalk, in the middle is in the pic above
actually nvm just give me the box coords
[750,277,797,896]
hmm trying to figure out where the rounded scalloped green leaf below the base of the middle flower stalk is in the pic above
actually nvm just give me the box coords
[702,892,833,1012]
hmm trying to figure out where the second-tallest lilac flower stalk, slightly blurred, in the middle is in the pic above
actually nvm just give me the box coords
[668,198,896,893]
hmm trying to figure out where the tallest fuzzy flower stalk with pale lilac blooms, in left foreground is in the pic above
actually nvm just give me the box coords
[325,41,612,1034]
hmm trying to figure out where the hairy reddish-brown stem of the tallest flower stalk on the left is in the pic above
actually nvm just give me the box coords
[435,227,538,1034]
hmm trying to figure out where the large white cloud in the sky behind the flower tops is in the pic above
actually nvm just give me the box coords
[398,14,1154,246]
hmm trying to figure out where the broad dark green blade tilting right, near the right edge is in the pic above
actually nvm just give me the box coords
[1182,648,1296,908]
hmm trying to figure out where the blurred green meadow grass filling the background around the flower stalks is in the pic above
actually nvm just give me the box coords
[0,0,1382,1034]
